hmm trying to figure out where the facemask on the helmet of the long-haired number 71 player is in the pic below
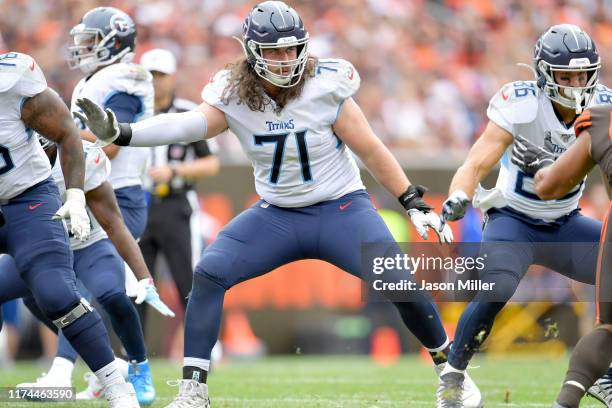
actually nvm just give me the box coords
[243,33,308,88]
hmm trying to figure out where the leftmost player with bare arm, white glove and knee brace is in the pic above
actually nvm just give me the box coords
[0,52,139,408]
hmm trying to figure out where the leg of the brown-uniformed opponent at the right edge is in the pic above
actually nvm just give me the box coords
[557,207,612,408]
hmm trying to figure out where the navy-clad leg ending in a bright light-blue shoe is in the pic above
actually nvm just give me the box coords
[74,239,155,405]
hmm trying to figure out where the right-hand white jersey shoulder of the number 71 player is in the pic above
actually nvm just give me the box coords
[315,58,361,100]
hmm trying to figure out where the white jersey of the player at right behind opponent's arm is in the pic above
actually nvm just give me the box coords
[487,81,612,222]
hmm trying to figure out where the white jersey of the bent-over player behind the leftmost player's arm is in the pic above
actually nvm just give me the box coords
[52,140,111,250]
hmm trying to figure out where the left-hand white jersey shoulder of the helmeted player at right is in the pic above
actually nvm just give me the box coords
[487,81,539,127]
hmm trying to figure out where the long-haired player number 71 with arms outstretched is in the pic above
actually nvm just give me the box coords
[77,1,480,408]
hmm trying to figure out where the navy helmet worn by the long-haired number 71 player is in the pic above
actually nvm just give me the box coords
[242,1,308,88]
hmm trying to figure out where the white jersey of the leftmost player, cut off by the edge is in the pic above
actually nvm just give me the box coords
[0,52,51,200]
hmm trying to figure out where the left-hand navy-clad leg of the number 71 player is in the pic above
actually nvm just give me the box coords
[169,201,302,407]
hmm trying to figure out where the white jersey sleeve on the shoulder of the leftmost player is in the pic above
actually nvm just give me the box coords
[0,52,47,98]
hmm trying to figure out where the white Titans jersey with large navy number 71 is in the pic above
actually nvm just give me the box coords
[202,59,364,207]
